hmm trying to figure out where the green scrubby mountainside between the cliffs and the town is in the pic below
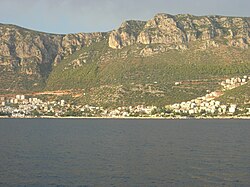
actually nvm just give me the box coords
[46,41,250,107]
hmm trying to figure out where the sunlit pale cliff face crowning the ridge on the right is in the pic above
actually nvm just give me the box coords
[109,14,250,49]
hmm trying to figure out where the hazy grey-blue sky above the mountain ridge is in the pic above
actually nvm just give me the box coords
[0,0,250,33]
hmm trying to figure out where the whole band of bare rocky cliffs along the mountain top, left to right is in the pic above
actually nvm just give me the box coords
[0,14,250,89]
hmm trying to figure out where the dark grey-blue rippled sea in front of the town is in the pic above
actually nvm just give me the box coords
[0,119,250,186]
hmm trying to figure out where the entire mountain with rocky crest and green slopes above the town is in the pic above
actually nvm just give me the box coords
[0,14,250,105]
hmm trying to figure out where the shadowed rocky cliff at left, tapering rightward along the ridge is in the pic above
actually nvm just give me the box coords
[0,24,106,90]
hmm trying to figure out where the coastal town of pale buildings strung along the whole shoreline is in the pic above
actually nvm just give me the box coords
[0,76,250,118]
